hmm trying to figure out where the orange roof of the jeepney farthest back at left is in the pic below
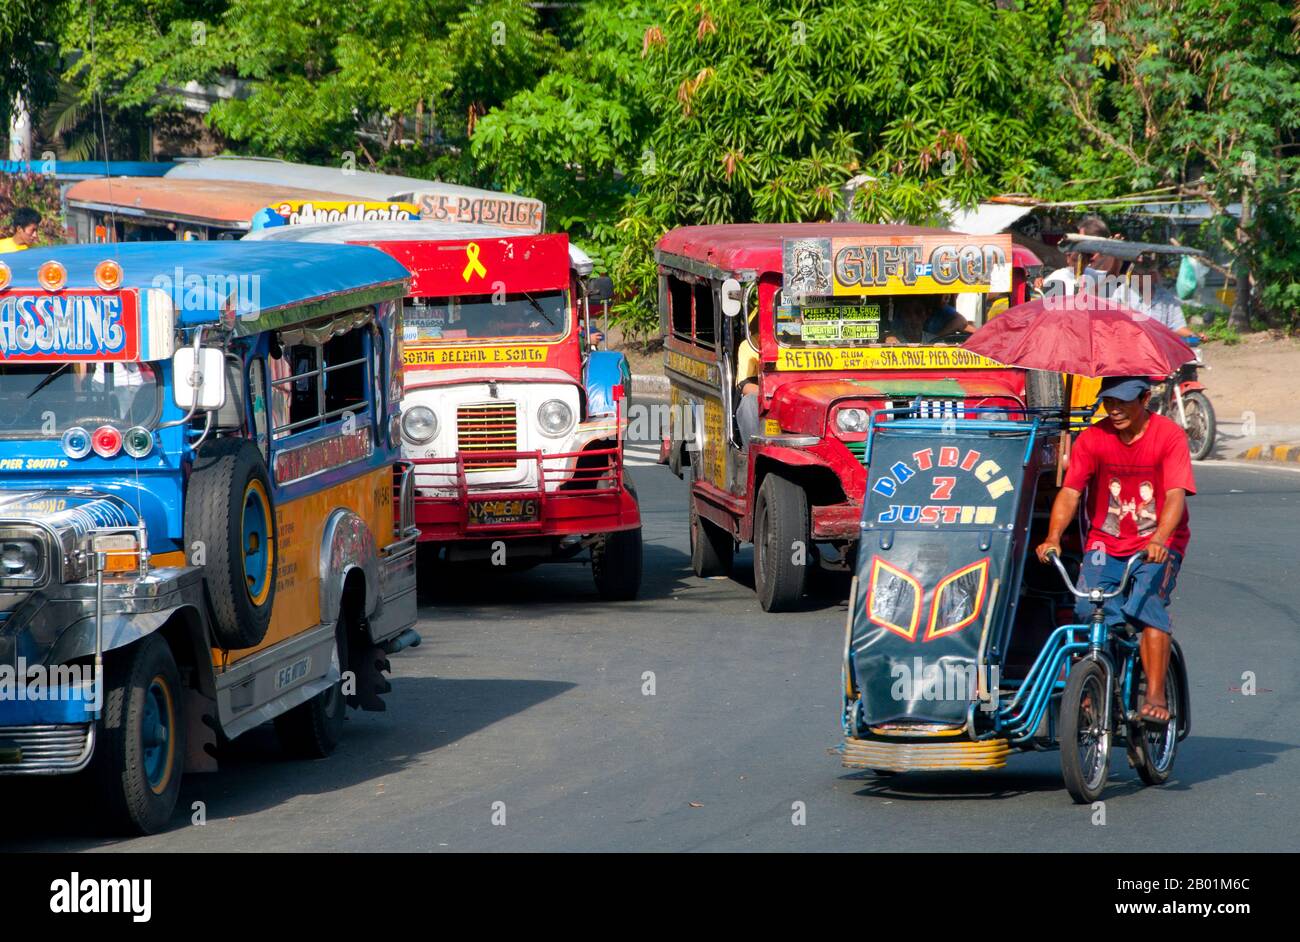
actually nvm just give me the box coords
[68,175,352,229]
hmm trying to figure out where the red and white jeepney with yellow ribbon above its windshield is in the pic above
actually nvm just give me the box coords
[248,221,641,600]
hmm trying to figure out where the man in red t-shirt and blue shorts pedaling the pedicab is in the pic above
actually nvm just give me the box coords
[1037,377,1196,726]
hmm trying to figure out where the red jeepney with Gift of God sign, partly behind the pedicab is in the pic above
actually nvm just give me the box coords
[655,223,1063,612]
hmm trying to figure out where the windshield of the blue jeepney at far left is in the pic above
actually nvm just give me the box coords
[0,363,161,438]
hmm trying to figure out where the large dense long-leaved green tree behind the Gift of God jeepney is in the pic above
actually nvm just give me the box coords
[475,0,1053,330]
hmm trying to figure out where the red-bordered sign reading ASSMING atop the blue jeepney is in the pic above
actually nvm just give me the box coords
[0,290,140,363]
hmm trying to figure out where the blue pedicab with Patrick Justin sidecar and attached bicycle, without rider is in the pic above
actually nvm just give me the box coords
[842,408,1190,802]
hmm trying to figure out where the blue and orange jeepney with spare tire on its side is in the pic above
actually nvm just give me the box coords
[0,242,419,833]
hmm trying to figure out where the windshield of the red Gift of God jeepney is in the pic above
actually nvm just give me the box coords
[772,292,984,347]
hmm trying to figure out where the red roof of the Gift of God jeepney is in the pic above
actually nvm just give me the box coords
[655,222,1039,274]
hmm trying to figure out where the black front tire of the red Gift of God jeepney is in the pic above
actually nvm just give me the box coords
[754,474,814,612]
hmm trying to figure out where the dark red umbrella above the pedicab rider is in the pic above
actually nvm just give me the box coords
[962,294,1196,377]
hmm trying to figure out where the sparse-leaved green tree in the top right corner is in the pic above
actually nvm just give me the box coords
[1058,0,1300,329]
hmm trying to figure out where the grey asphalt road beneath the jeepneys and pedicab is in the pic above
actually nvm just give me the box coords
[0,465,1300,852]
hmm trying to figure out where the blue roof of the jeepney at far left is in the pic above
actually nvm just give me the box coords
[0,242,410,335]
